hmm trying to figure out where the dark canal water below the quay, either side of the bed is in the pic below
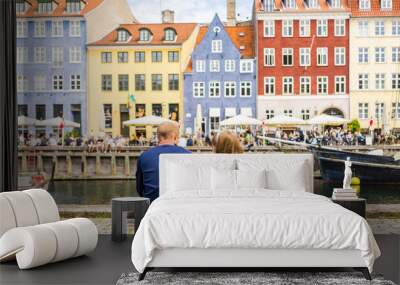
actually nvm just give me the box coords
[49,179,400,205]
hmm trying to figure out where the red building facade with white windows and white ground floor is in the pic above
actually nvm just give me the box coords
[255,0,349,119]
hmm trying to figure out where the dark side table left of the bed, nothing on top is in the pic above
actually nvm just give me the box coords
[111,197,150,241]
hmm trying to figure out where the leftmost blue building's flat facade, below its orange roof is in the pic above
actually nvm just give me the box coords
[17,15,87,134]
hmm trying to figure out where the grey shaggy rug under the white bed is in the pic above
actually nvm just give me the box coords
[117,272,395,285]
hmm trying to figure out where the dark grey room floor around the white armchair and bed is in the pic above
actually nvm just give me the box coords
[0,235,400,285]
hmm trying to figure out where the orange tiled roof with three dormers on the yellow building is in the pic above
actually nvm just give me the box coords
[90,23,197,46]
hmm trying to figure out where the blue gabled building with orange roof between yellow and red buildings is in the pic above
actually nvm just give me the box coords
[184,15,257,135]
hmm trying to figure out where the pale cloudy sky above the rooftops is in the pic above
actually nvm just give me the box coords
[128,0,253,23]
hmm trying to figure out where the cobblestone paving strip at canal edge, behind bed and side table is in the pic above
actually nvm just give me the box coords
[86,218,400,235]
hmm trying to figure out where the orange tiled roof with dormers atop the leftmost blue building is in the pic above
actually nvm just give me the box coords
[18,0,104,17]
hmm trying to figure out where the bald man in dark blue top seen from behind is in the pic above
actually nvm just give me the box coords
[136,122,190,202]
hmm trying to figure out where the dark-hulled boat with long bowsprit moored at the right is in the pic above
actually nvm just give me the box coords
[260,137,400,184]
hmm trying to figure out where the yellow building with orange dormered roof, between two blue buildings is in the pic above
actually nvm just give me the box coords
[87,23,198,138]
